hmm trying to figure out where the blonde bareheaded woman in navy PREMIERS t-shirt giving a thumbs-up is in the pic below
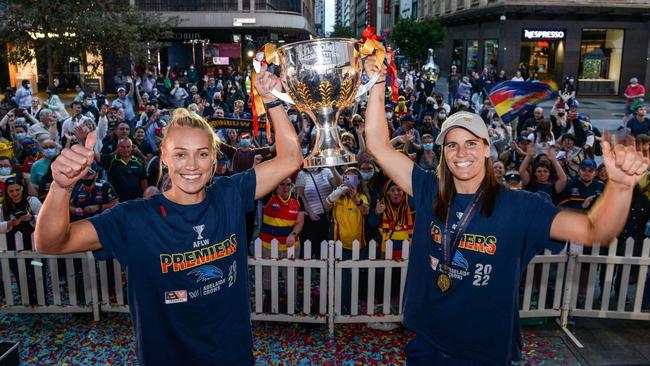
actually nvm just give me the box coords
[35,66,302,365]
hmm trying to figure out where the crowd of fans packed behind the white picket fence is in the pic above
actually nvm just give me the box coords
[0,65,650,308]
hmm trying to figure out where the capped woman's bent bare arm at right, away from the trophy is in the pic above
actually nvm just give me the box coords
[551,141,650,246]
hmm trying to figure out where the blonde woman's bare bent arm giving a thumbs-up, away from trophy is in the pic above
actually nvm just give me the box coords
[34,132,101,254]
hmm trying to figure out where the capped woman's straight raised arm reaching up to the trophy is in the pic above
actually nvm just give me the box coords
[365,56,413,196]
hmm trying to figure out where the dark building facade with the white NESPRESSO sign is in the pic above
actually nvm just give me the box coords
[418,0,650,95]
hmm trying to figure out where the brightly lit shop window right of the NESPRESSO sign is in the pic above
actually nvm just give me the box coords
[578,29,625,94]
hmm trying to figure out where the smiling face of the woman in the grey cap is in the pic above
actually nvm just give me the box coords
[444,128,490,193]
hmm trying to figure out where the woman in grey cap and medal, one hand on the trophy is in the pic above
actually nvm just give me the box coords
[365,55,648,365]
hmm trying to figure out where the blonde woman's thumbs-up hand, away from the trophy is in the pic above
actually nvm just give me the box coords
[52,132,97,188]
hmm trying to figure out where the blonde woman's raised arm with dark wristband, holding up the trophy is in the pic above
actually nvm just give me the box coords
[254,65,302,199]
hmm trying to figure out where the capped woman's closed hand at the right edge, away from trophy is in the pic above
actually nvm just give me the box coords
[602,141,650,189]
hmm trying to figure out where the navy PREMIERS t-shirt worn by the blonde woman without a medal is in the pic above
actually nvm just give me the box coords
[90,170,255,365]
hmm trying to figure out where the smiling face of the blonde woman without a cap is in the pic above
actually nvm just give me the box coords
[162,127,216,201]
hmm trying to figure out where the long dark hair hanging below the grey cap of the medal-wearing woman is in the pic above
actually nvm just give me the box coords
[433,140,501,221]
